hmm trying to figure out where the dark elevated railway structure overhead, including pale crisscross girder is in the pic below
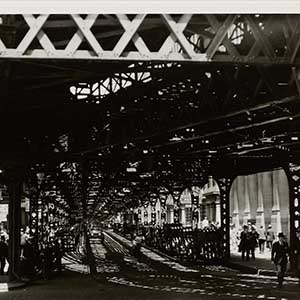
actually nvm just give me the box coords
[0,14,300,217]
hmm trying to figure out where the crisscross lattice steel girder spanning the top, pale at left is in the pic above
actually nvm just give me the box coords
[0,14,300,65]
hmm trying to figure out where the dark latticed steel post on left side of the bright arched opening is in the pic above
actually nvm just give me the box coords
[216,178,234,259]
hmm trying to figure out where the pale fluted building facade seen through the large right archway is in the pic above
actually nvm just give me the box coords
[230,169,290,236]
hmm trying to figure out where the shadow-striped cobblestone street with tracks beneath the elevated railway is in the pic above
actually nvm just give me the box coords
[0,239,300,300]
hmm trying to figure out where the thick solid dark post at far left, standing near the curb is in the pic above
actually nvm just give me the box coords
[8,170,23,281]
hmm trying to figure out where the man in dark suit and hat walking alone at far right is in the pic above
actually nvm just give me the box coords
[271,232,289,289]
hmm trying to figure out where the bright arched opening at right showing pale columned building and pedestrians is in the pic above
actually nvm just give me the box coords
[230,169,290,260]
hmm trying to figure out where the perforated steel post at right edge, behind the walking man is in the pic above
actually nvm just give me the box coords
[284,163,300,268]
